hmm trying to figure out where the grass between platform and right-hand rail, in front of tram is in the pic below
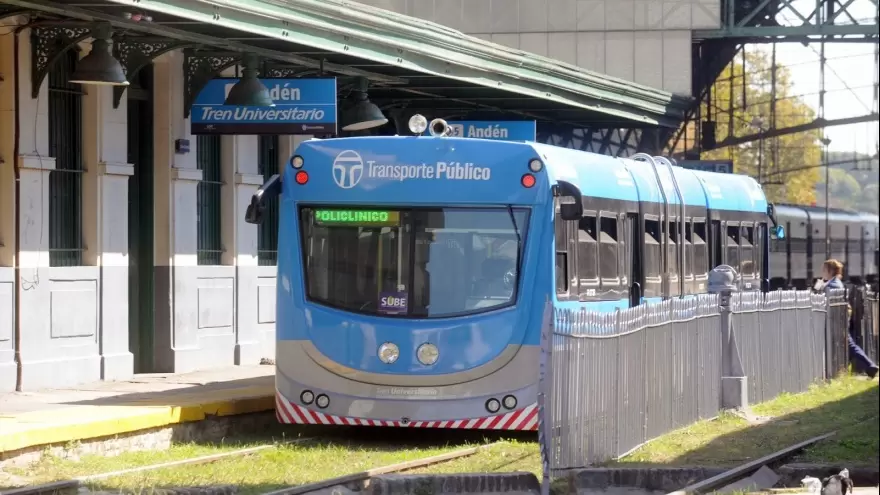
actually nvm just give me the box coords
[0,428,492,494]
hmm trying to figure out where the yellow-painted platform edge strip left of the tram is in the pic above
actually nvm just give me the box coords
[0,394,275,453]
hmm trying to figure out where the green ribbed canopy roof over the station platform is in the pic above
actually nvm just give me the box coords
[0,0,690,128]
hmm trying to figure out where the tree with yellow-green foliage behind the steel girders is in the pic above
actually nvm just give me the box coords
[701,51,822,204]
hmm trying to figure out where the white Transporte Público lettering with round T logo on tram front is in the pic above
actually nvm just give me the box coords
[333,150,492,189]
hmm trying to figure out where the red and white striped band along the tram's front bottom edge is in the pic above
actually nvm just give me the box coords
[275,393,538,431]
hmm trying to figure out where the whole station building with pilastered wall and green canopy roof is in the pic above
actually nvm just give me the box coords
[0,0,689,392]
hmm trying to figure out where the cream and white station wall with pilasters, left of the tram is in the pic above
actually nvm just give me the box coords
[0,35,278,393]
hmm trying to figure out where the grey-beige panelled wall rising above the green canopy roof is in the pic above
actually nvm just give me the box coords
[359,0,720,95]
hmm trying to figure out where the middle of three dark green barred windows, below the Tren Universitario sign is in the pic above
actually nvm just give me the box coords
[196,136,223,265]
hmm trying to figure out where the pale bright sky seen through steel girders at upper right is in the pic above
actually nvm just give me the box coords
[749,0,880,155]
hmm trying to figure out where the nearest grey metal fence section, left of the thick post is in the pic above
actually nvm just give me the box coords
[545,294,721,472]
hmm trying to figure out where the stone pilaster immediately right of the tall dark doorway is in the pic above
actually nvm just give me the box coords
[153,51,208,372]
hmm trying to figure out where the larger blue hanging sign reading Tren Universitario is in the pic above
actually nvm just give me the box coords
[190,77,337,134]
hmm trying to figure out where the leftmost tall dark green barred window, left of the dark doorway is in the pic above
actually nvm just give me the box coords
[49,50,85,266]
